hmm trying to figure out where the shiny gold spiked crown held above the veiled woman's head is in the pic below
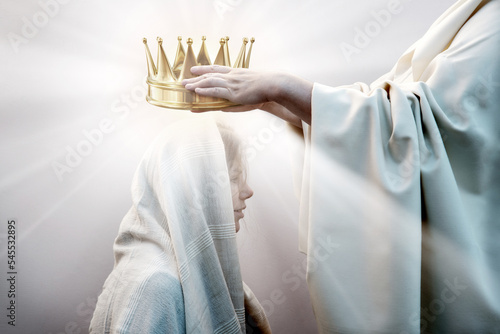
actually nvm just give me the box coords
[143,36,255,110]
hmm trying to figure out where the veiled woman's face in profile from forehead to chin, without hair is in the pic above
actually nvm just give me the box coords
[229,163,253,232]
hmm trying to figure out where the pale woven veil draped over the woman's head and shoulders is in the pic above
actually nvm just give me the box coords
[90,117,270,334]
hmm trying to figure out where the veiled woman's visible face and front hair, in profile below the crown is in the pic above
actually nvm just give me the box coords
[217,123,253,232]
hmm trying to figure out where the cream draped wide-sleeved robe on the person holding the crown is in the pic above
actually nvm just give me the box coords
[300,0,500,333]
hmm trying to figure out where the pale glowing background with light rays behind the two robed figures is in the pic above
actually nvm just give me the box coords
[0,0,453,333]
